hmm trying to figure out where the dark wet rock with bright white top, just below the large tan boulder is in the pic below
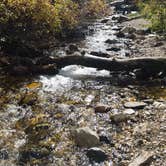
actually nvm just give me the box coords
[87,147,108,163]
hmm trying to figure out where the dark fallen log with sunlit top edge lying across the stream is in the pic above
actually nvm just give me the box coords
[53,55,166,72]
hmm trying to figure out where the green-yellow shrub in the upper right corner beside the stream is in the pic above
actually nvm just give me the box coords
[139,0,166,32]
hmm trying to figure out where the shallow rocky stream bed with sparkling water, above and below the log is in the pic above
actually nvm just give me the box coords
[0,1,166,166]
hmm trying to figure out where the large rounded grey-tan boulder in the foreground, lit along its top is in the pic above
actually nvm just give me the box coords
[72,127,100,147]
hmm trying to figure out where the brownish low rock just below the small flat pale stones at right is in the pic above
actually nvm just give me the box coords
[110,113,132,123]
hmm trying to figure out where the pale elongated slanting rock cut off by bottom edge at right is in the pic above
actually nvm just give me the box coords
[129,151,154,166]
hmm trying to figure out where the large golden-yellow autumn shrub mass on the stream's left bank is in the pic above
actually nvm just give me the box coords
[0,0,105,56]
